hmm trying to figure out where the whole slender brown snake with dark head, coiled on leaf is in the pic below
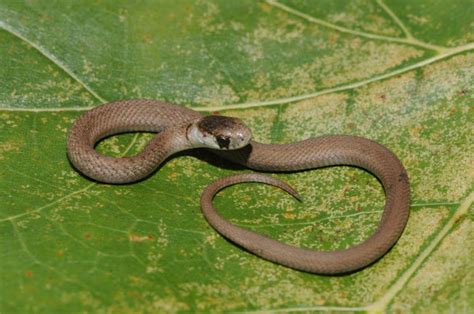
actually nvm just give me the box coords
[67,99,410,275]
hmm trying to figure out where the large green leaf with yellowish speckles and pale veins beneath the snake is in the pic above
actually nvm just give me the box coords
[0,0,474,313]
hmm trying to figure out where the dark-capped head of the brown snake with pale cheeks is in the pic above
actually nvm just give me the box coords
[187,115,252,150]
